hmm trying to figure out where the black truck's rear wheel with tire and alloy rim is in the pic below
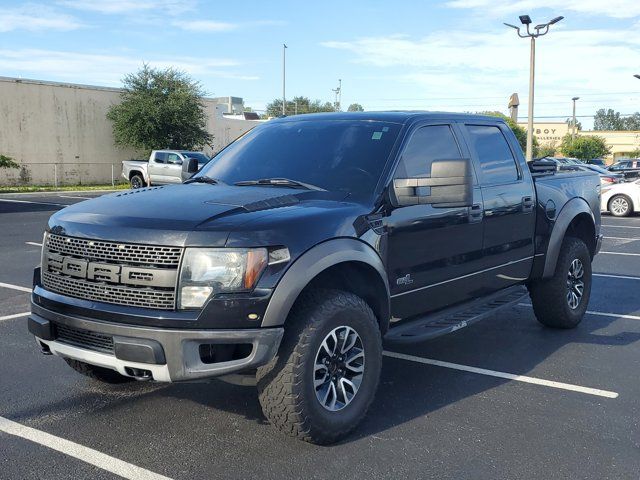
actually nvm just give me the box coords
[529,237,591,328]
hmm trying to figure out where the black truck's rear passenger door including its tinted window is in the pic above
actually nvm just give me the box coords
[464,122,535,294]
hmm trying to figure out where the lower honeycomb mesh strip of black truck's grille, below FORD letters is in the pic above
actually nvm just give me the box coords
[42,272,175,310]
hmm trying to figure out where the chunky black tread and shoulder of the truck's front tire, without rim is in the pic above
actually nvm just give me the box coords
[256,289,382,445]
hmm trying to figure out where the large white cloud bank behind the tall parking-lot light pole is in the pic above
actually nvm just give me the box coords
[322,27,640,125]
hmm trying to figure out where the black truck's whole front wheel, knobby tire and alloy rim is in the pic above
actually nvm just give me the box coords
[257,289,382,445]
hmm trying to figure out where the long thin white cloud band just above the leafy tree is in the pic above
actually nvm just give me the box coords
[0,49,259,87]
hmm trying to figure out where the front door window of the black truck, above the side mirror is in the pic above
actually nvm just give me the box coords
[396,125,462,178]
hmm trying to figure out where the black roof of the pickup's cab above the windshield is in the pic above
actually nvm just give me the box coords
[271,110,504,123]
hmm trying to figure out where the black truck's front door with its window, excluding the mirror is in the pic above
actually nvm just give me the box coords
[384,123,482,318]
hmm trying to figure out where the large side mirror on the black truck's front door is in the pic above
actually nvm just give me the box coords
[391,158,473,208]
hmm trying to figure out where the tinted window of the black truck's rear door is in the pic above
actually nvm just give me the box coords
[467,125,519,184]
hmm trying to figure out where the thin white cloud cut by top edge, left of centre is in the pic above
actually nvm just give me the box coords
[57,0,195,15]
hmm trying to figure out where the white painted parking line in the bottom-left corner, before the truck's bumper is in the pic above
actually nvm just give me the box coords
[0,417,171,480]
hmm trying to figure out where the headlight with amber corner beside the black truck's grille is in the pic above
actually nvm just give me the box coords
[178,248,269,309]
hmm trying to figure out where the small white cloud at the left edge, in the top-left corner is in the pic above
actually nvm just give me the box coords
[0,4,83,32]
